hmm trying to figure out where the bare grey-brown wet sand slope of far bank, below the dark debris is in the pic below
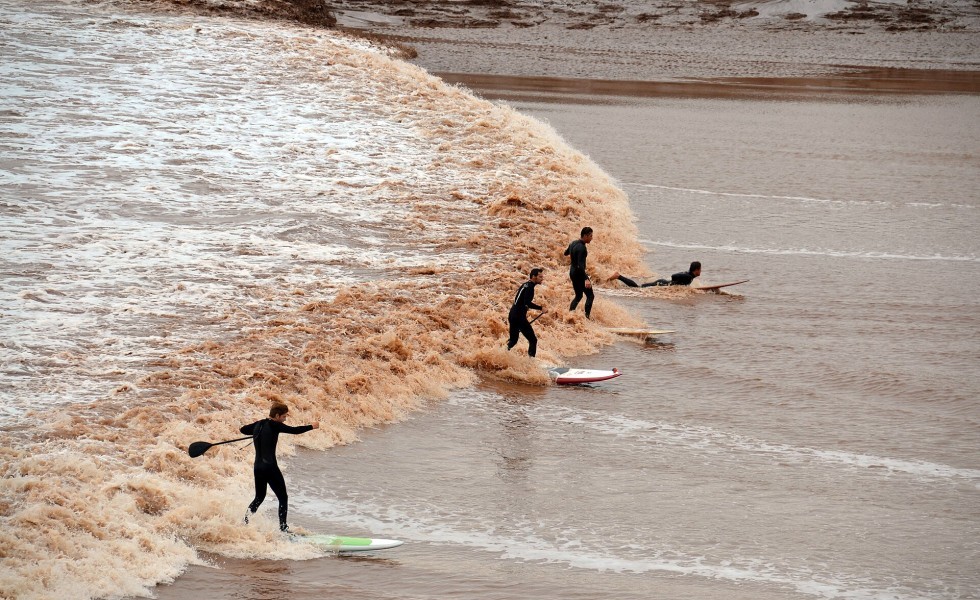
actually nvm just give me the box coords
[324,2,980,103]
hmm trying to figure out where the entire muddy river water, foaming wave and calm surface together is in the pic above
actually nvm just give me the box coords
[0,3,980,599]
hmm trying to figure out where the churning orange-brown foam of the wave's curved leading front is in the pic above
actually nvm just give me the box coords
[0,17,660,598]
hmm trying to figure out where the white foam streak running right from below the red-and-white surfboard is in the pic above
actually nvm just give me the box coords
[537,407,980,482]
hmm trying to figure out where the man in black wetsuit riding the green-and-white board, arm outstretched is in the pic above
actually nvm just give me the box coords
[240,404,320,533]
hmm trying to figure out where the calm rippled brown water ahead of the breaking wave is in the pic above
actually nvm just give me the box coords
[153,72,980,599]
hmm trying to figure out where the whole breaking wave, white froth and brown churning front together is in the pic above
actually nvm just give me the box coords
[0,0,642,598]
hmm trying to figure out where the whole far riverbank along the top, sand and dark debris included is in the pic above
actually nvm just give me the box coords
[124,0,980,88]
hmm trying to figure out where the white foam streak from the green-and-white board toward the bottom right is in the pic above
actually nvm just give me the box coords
[295,496,939,600]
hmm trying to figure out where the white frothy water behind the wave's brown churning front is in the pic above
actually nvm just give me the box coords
[0,0,494,418]
